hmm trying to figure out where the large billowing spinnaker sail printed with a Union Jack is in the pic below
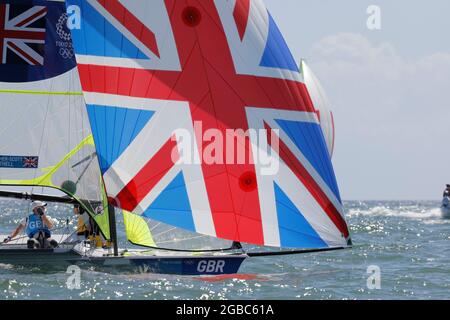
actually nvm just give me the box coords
[66,0,350,248]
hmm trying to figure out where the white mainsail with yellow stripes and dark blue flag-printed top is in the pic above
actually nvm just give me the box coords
[0,0,110,238]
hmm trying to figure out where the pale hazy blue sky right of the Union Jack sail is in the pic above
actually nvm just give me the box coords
[265,0,450,199]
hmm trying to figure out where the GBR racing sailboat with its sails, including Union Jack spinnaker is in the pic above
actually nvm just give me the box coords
[0,0,351,275]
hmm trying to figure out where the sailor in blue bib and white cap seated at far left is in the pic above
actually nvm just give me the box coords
[3,201,58,249]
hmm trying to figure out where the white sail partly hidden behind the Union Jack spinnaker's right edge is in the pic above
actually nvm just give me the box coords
[301,60,335,156]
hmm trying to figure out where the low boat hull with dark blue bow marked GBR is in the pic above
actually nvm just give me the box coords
[0,238,247,275]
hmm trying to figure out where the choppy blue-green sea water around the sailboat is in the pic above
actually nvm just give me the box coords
[0,200,450,300]
